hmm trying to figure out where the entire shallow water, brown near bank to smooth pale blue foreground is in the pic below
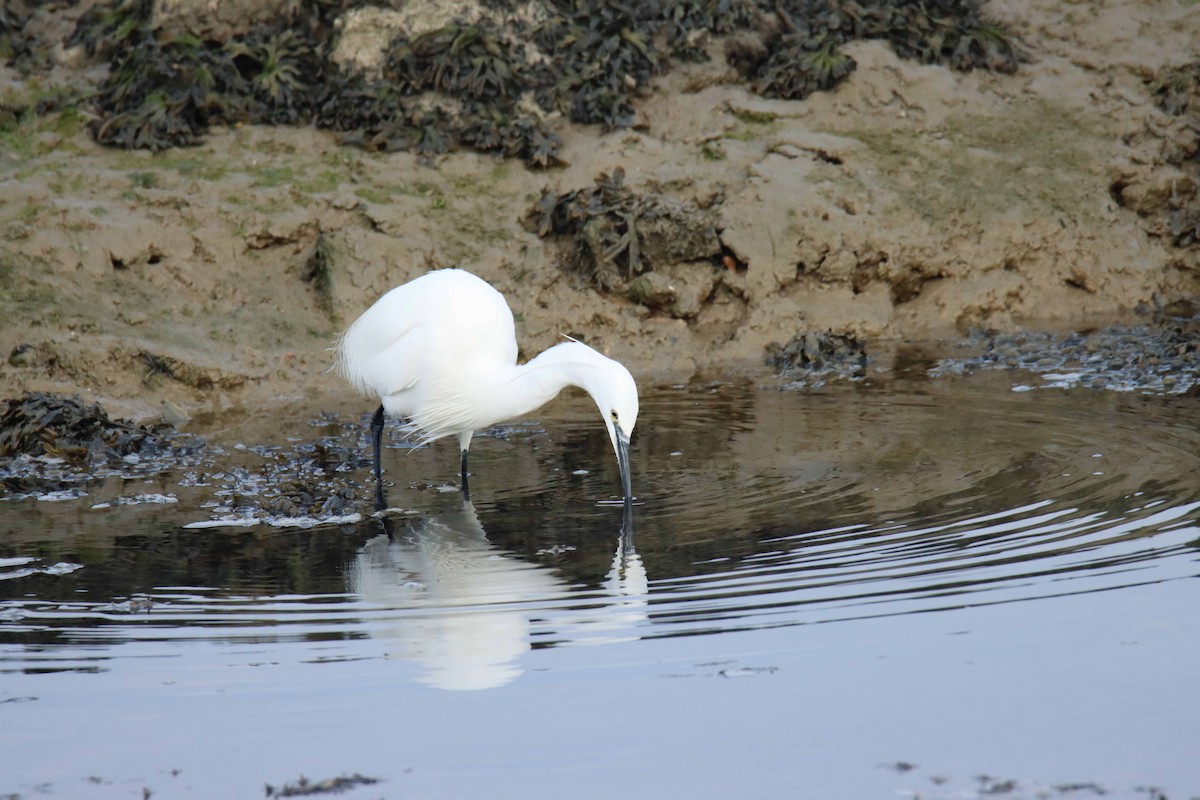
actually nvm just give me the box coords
[0,373,1200,799]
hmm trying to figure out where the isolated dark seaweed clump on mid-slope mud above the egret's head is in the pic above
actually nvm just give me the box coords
[526,167,721,291]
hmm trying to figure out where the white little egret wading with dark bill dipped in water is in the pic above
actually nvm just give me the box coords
[337,270,637,506]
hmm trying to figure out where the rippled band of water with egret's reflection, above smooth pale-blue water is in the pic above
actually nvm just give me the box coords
[0,375,1200,688]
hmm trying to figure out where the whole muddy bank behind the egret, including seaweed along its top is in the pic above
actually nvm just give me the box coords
[0,0,1200,421]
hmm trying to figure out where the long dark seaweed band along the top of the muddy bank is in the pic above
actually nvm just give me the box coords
[68,0,1024,167]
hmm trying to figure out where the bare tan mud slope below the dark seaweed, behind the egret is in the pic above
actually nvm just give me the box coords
[0,0,1200,419]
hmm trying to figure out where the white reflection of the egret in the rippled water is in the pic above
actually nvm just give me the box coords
[347,500,648,690]
